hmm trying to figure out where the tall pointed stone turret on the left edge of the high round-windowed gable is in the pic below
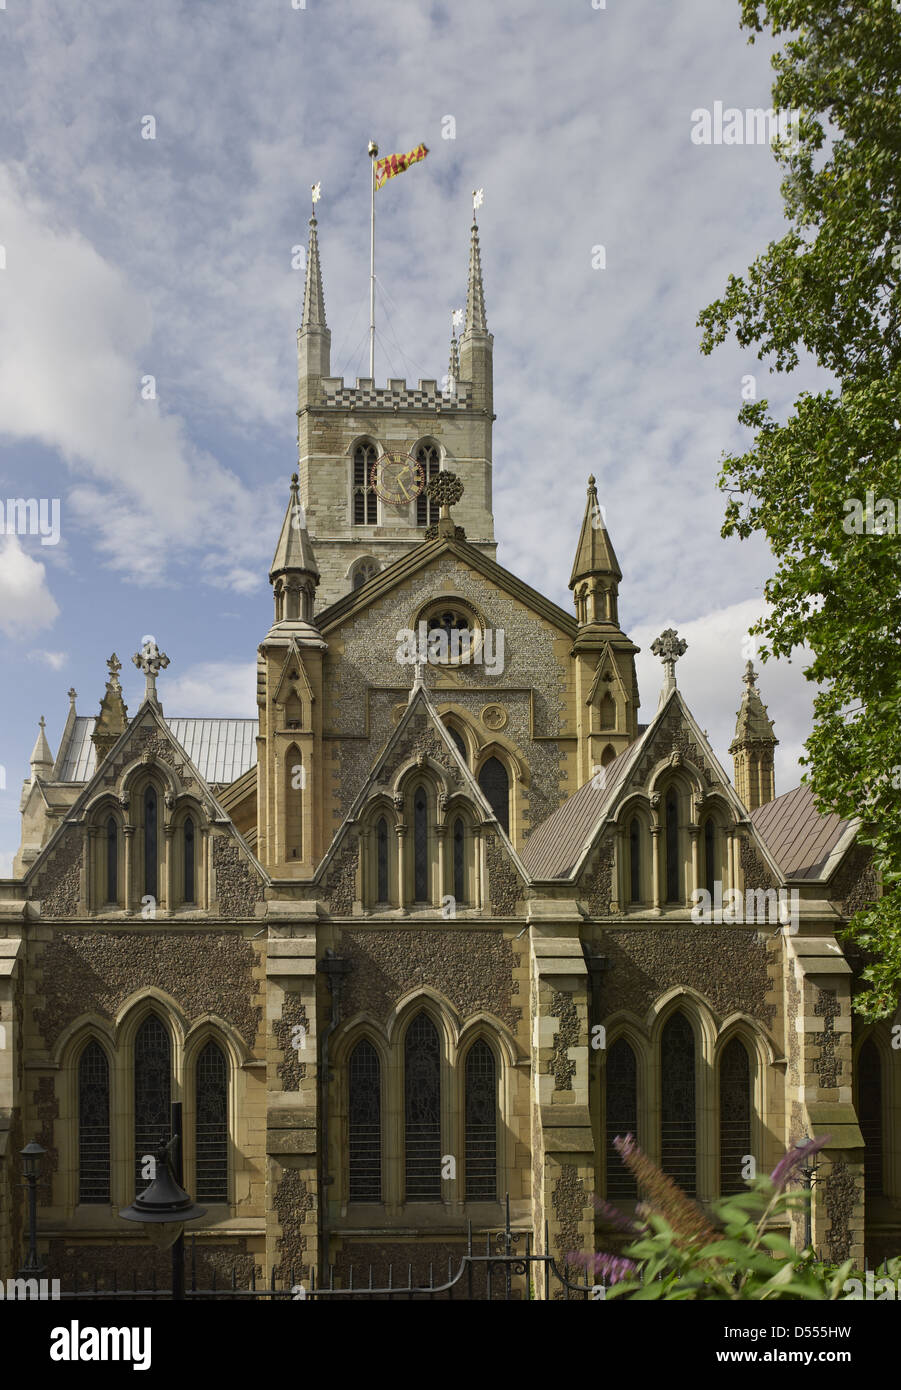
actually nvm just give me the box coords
[256,473,327,878]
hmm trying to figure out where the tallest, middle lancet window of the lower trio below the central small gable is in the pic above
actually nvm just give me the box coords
[403,1013,441,1202]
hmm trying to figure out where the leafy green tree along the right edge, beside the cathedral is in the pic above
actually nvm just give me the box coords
[698,0,901,1019]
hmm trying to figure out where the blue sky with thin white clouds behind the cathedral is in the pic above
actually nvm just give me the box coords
[0,0,826,874]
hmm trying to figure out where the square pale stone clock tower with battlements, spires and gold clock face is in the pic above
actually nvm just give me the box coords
[298,207,496,610]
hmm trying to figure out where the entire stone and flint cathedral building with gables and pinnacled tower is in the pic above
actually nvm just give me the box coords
[0,208,884,1294]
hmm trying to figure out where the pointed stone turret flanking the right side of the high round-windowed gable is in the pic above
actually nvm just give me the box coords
[569,477,638,785]
